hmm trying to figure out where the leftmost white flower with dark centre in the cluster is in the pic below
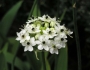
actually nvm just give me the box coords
[16,30,30,43]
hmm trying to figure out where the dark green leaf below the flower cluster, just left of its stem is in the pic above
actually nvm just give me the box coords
[26,51,41,70]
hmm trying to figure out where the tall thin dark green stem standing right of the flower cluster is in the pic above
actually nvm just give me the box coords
[73,0,81,70]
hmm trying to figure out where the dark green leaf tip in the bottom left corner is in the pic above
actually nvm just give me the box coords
[0,52,8,70]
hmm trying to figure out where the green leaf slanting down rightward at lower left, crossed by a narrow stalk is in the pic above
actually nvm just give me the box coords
[3,52,30,70]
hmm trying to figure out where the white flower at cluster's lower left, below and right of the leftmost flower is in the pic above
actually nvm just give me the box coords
[22,37,36,51]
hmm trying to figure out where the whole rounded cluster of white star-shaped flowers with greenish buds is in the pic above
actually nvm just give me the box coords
[16,15,73,54]
